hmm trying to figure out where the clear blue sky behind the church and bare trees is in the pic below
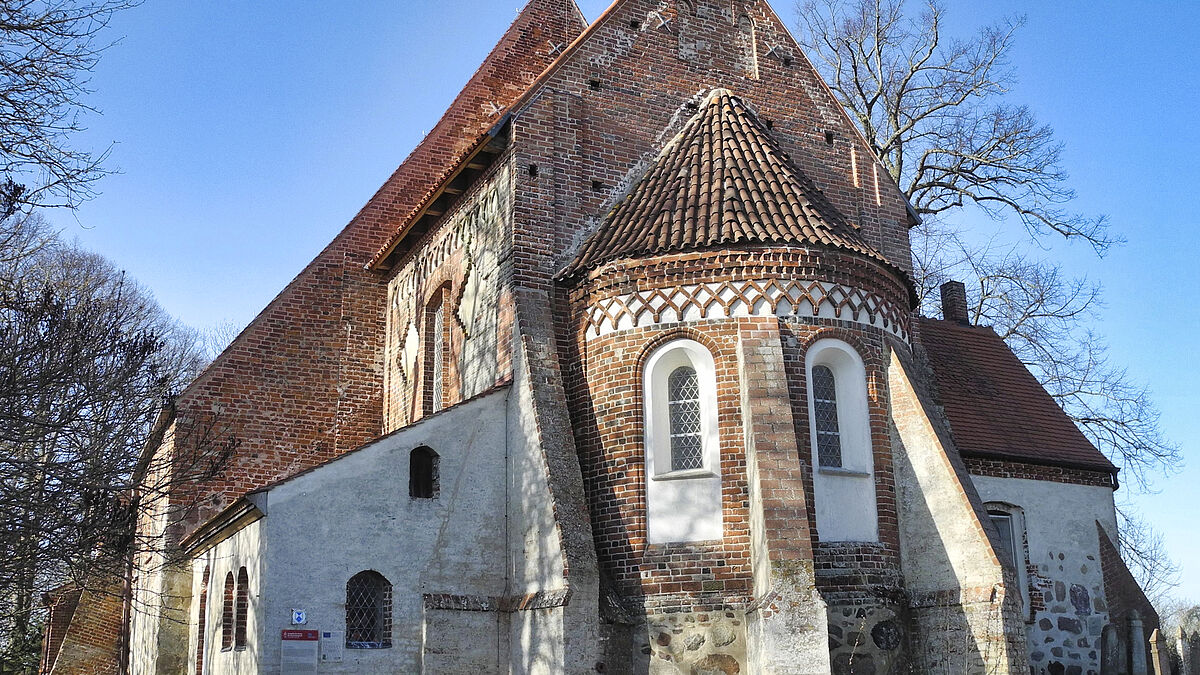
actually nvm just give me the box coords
[50,0,1200,602]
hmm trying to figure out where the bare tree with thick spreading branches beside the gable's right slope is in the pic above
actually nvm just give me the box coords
[799,0,1112,251]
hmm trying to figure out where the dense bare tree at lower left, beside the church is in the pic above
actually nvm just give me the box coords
[0,213,233,673]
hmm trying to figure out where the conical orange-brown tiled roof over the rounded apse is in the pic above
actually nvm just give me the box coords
[563,89,895,276]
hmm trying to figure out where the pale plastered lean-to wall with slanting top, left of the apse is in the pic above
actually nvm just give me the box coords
[246,387,565,673]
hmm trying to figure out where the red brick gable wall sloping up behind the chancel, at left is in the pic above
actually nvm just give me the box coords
[166,0,584,525]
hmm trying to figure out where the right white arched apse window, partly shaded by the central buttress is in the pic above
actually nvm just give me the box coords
[805,339,880,542]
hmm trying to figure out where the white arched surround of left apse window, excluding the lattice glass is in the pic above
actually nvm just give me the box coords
[642,339,724,544]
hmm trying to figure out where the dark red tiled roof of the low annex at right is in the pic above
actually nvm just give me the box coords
[920,318,1116,472]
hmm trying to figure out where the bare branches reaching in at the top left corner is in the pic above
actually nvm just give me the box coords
[0,0,139,207]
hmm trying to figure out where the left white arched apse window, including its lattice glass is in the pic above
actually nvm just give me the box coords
[642,340,724,544]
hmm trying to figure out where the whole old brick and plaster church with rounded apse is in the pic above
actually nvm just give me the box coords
[43,0,1157,675]
